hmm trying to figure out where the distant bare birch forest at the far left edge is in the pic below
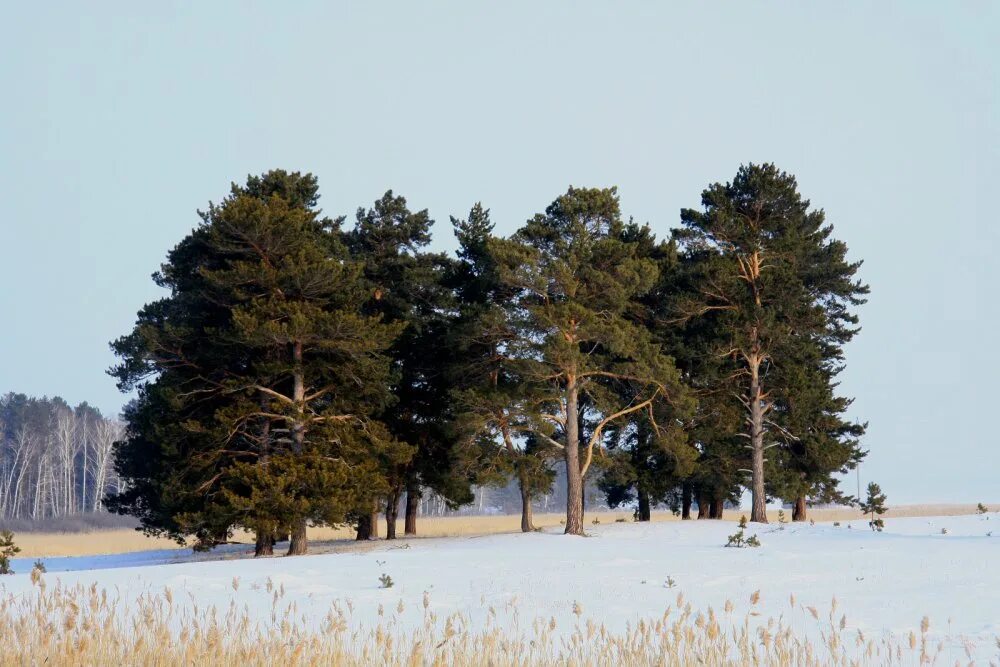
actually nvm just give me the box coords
[0,393,124,520]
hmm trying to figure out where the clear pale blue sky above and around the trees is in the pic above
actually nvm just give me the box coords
[0,0,1000,502]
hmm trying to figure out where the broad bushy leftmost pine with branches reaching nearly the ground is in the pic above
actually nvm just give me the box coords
[103,172,406,554]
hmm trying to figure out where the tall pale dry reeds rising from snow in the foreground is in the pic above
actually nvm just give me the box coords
[0,574,988,666]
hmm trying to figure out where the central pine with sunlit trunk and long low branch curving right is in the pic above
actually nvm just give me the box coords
[497,188,682,535]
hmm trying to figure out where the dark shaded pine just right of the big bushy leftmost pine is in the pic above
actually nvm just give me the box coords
[344,191,473,539]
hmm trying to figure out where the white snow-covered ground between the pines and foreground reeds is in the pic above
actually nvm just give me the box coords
[0,513,1000,659]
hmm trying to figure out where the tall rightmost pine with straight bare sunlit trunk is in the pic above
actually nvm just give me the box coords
[676,164,868,523]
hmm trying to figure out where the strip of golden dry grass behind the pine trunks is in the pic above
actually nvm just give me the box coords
[9,504,992,558]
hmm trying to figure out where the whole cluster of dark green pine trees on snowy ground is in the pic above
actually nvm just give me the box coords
[106,164,868,554]
